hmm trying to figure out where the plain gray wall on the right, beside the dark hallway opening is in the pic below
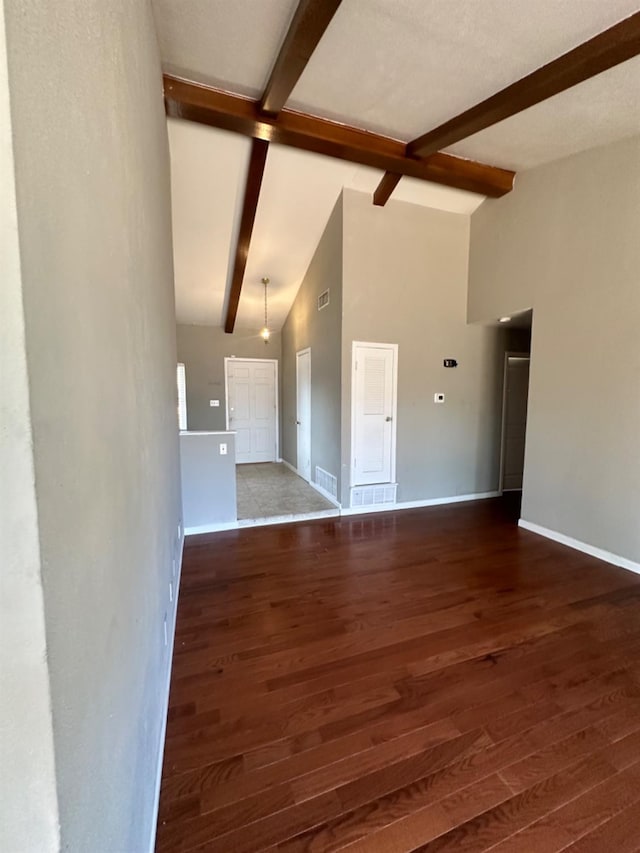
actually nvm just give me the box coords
[468,137,640,562]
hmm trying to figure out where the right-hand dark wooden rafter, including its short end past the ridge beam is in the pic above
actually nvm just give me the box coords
[374,12,640,205]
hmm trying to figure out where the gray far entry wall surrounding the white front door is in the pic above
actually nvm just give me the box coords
[176,325,281,430]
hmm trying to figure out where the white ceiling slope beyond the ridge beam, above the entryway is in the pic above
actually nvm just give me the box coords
[168,119,484,329]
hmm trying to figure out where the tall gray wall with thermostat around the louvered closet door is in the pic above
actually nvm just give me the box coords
[342,190,504,506]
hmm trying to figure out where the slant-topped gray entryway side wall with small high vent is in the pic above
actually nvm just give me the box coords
[281,198,342,495]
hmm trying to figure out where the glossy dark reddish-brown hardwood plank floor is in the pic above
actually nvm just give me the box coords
[157,500,640,853]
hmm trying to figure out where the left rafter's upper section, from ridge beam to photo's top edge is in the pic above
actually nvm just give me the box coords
[259,0,341,116]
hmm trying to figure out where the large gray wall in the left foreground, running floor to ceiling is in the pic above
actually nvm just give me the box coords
[5,0,180,853]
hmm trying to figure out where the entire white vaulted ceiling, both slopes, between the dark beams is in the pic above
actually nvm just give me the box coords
[154,0,640,328]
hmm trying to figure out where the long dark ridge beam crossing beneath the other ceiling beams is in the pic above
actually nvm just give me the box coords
[164,75,515,198]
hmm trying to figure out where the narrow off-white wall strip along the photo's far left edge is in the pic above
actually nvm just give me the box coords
[0,2,59,853]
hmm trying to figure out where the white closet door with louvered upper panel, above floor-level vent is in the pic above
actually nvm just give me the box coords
[351,343,397,486]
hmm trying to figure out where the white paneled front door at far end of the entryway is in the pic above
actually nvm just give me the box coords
[226,358,276,463]
